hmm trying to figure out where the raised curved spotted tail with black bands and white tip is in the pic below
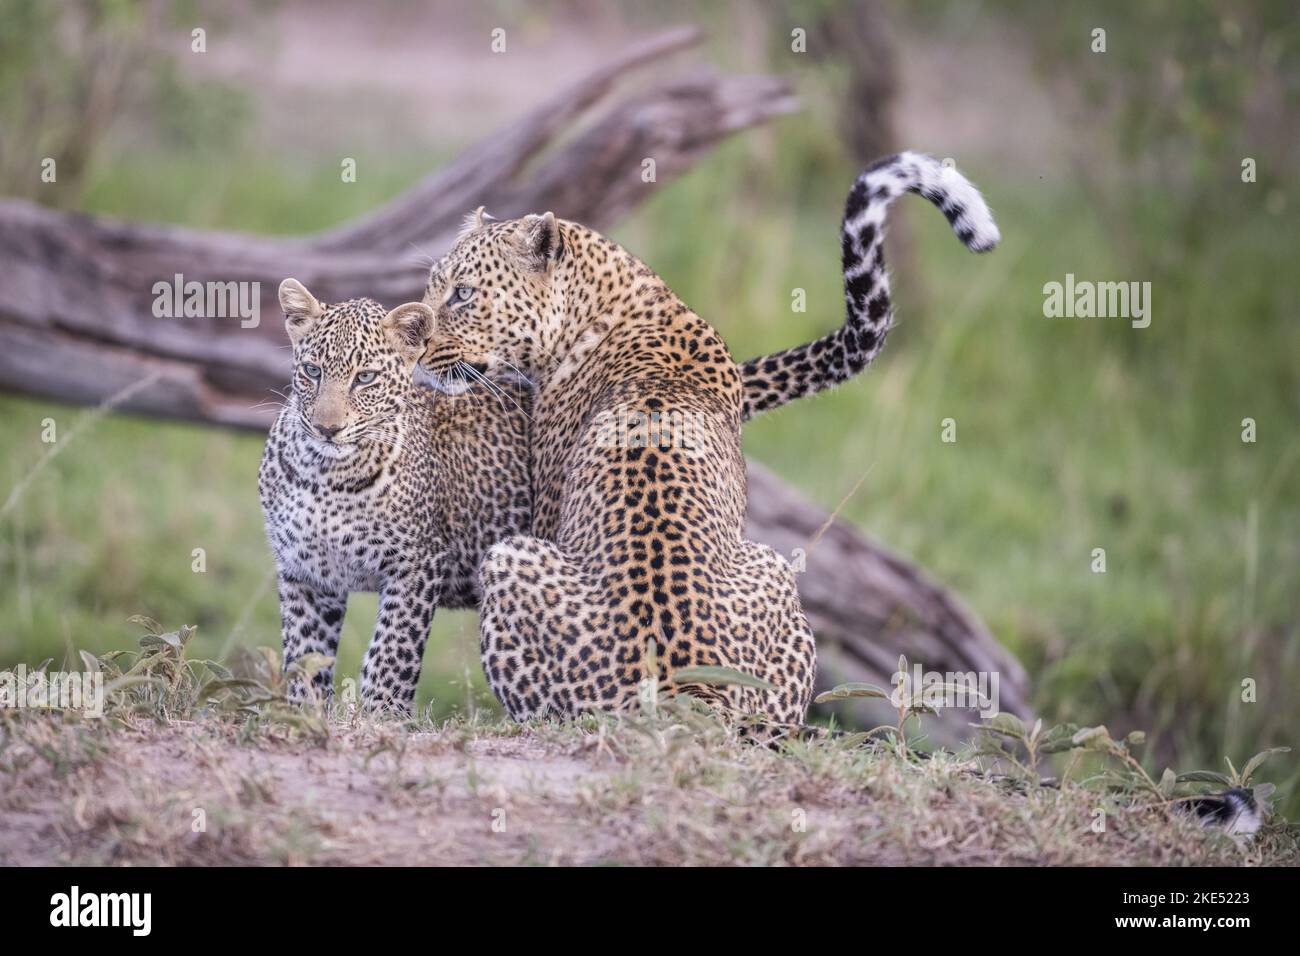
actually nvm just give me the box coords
[741,152,1001,419]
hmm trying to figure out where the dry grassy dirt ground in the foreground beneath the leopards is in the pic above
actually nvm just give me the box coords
[0,717,1300,866]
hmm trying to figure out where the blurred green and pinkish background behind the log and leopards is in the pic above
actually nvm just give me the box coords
[0,0,1300,809]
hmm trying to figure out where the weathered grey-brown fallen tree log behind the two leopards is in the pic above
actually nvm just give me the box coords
[0,30,1026,727]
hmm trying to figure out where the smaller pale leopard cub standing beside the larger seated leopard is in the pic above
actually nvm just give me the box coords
[257,278,532,711]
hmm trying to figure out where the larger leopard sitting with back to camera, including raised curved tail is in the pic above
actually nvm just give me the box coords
[416,153,998,724]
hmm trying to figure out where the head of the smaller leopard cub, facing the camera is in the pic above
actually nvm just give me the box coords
[280,278,433,458]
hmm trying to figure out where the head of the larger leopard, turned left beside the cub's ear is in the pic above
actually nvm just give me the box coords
[415,208,569,394]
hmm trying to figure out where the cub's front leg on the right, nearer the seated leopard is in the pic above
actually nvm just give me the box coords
[361,555,445,714]
